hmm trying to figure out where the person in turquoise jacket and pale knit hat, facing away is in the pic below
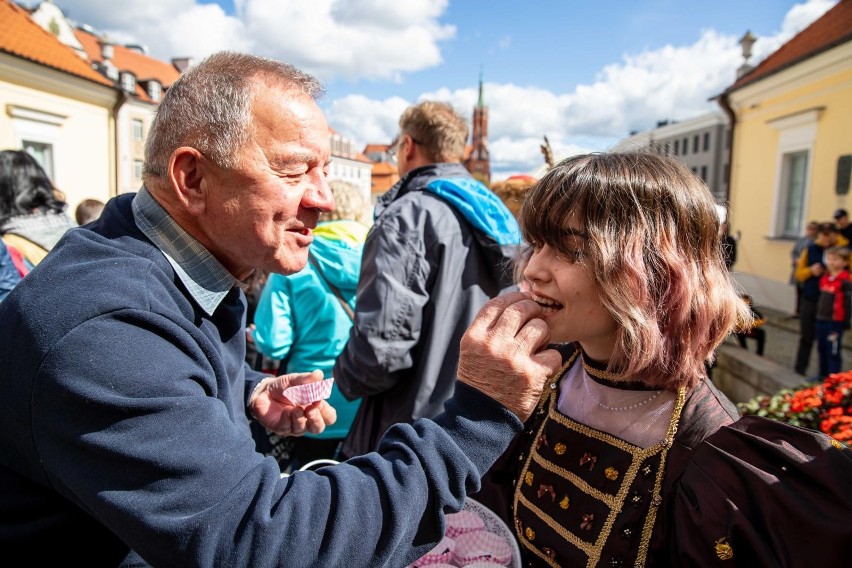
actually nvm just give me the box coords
[251,180,369,470]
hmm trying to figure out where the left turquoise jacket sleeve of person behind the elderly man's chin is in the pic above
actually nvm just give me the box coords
[253,274,293,359]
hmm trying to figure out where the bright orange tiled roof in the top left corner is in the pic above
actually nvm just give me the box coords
[0,0,113,87]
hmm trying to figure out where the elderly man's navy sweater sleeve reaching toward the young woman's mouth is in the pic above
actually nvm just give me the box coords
[32,310,521,567]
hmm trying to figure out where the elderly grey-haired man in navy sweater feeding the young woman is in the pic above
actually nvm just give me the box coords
[0,53,559,566]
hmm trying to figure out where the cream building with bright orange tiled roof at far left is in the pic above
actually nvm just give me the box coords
[0,0,117,215]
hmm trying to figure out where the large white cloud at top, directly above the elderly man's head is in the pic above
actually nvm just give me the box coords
[51,0,455,81]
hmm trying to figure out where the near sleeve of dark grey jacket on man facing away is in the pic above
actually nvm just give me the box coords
[334,202,431,400]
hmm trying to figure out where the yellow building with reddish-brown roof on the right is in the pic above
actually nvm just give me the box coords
[719,0,852,313]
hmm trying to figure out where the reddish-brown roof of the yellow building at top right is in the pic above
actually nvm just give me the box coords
[727,0,852,93]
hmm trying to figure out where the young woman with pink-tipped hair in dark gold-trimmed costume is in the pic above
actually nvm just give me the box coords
[498,154,852,566]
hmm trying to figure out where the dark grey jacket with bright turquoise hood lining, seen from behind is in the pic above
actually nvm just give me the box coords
[334,163,521,457]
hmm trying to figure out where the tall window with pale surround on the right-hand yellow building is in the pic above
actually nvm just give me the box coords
[769,109,822,238]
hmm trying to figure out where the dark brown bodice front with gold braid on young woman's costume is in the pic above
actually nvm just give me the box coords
[513,357,686,567]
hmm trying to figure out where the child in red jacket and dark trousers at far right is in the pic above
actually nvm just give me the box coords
[811,246,852,381]
